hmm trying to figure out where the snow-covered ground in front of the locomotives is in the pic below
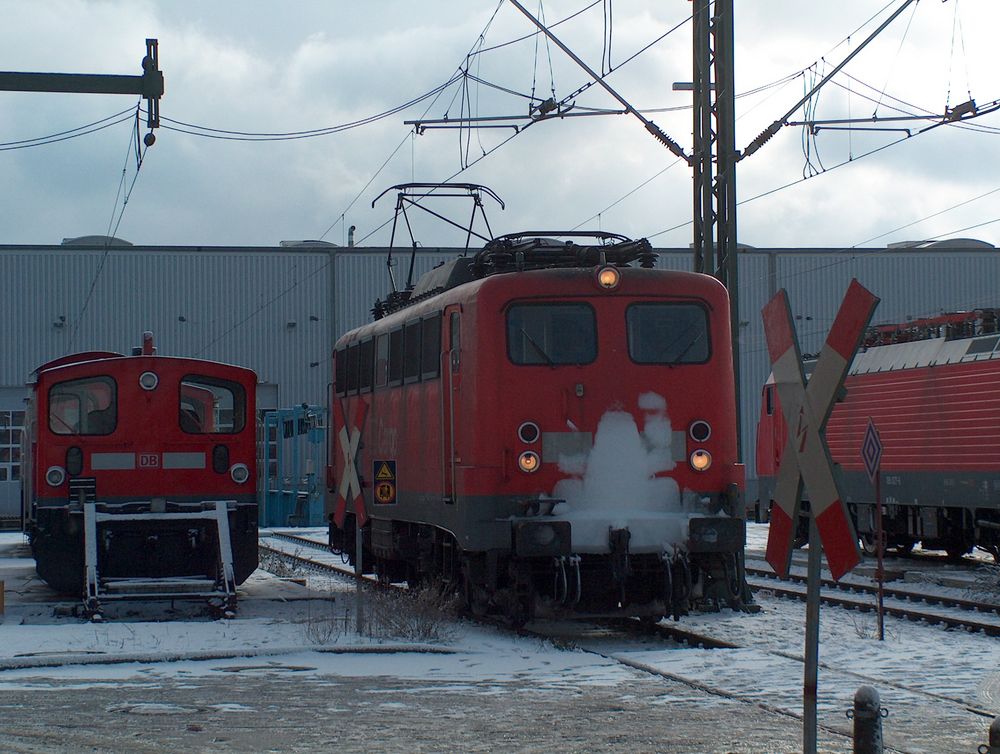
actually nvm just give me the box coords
[0,525,1000,753]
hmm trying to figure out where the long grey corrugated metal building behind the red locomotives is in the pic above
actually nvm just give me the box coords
[0,237,1000,519]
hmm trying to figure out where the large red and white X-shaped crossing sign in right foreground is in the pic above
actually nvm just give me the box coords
[763,280,879,579]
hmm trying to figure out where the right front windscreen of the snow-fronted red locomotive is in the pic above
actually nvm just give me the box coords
[625,303,711,364]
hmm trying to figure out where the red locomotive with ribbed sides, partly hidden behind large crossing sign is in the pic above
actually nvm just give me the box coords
[757,309,1000,558]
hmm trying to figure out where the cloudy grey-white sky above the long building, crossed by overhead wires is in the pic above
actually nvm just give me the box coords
[0,0,1000,247]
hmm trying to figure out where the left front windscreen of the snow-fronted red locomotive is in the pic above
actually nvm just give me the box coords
[507,303,597,366]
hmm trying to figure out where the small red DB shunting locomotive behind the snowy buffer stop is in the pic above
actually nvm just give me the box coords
[22,333,257,615]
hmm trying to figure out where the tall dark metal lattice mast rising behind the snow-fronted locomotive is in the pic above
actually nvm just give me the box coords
[691,0,743,459]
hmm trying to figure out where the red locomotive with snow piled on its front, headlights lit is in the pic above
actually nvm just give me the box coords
[330,232,744,621]
